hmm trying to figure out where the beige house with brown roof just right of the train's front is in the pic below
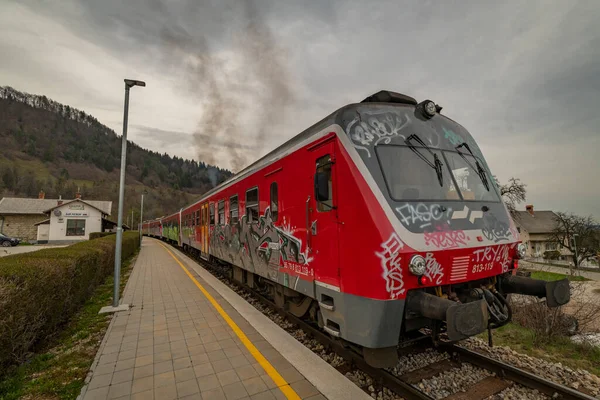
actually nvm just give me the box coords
[514,204,570,258]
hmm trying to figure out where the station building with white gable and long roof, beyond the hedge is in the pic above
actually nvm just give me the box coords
[0,192,115,243]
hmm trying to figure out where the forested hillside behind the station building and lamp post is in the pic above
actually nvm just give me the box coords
[0,86,231,218]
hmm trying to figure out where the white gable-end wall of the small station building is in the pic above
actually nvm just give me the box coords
[48,201,102,242]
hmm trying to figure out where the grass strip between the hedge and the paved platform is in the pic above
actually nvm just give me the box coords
[0,250,139,400]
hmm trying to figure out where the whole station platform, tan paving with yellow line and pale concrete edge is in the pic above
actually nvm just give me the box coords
[79,238,371,400]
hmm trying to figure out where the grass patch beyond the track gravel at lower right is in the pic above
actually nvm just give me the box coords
[479,322,600,376]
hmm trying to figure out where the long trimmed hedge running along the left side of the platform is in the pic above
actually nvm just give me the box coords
[0,232,139,376]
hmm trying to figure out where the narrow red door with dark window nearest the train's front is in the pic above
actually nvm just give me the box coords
[307,138,340,290]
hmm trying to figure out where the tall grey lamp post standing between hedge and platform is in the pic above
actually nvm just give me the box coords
[113,79,146,308]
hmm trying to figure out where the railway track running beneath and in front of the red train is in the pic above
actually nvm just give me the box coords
[173,242,595,400]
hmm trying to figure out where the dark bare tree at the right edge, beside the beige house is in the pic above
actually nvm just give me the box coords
[550,212,600,265]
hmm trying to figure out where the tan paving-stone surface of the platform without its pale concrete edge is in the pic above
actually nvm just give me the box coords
[80,238,326,400]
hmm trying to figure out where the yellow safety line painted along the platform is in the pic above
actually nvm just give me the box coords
[158,242,300,400]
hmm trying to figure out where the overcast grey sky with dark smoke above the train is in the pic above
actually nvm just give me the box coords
[0,0,600,219]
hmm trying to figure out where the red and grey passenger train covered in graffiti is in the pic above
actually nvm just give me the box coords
[143,91,570,367]
